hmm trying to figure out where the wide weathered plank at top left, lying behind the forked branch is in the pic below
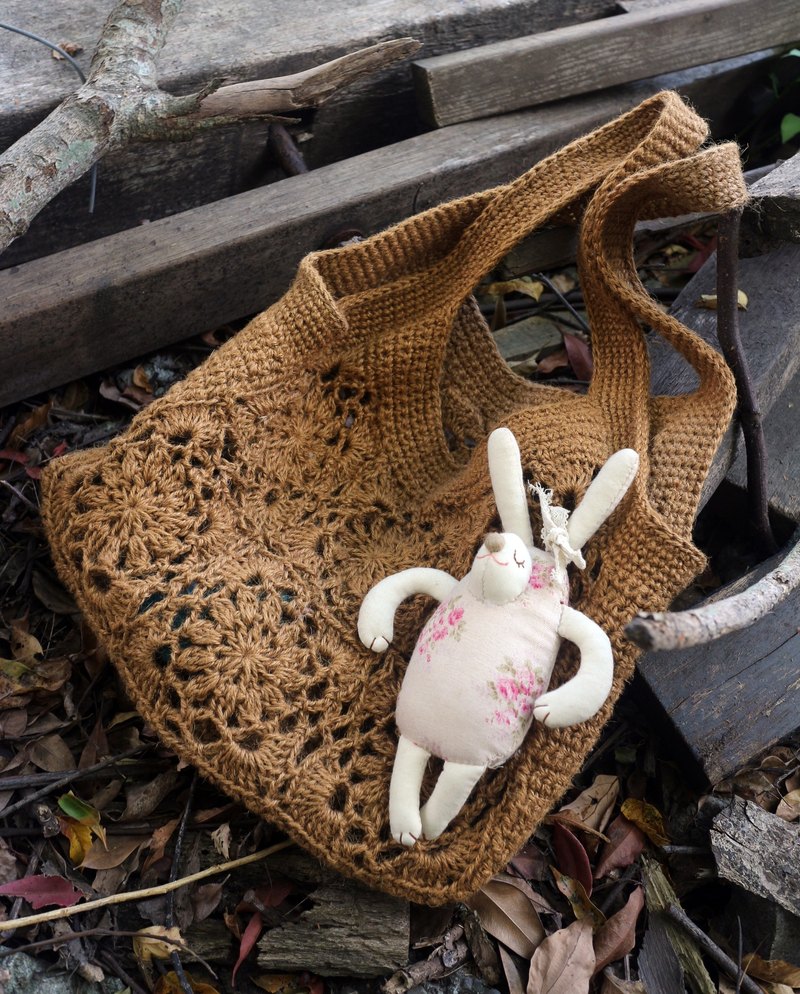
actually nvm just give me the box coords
[0,0,613,268]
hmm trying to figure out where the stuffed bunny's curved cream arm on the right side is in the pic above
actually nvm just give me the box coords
[533,607,614,728]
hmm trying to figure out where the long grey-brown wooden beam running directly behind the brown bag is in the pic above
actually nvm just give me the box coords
[0,82,708,406]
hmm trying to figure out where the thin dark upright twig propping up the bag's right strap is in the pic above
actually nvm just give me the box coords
[717,208,778,556]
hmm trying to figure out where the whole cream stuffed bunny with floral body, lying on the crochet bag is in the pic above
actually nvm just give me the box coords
[358,428,639,846]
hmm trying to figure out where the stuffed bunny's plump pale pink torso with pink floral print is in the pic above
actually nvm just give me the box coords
[396,553,567,766]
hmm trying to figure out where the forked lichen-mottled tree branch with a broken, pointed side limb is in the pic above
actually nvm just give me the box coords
[0,0,420,252]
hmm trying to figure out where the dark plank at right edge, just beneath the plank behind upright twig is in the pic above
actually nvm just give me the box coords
[727,364,800,523]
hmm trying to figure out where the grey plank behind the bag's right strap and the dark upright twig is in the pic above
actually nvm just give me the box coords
[650,243,800,504]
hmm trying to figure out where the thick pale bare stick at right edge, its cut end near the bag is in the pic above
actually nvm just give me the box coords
[625,528,800,649]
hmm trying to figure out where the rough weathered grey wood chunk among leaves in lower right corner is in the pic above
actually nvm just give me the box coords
[711,797,800,920]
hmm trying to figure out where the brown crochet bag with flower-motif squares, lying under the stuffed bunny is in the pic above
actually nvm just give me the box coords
[43,93,746,904]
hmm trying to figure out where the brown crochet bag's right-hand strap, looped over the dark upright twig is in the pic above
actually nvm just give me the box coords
[579,144,747,527]
